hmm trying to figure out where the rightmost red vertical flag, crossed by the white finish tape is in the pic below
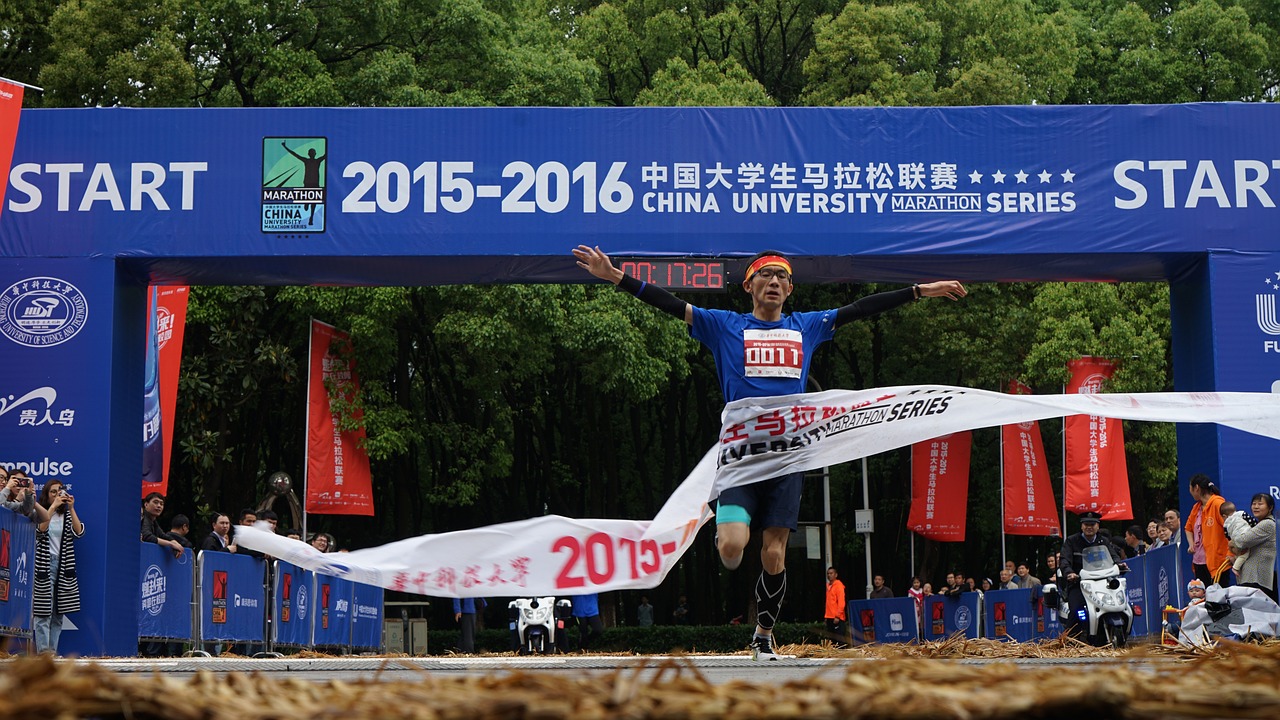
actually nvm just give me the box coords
[1062,357,1133,520]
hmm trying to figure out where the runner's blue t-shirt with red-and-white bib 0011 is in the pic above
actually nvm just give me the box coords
[689,306,836,402]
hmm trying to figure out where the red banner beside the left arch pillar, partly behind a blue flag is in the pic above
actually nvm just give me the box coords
[142,286,191,497]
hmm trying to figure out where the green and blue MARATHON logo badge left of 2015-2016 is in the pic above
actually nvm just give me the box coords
[261,137,329,233]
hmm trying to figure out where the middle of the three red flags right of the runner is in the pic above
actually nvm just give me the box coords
[1000,380,1061,537]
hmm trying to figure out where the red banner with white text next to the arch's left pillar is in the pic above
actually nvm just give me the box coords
[142,286,191,497]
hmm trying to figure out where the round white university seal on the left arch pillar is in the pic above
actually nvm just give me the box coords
[0,277,88,347]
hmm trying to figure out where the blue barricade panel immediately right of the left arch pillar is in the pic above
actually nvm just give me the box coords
[138,542,196,639]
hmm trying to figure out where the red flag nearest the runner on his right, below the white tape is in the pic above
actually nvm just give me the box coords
[906,430,973,542]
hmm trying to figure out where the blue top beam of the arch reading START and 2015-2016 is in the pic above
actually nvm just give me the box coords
[0,102,1280,283]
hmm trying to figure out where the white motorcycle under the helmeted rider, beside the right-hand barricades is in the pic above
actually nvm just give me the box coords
[1042,544,1133,648]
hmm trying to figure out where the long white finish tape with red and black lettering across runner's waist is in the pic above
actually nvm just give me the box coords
[236,386,1280,597]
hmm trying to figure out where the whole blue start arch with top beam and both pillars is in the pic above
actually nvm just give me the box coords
[0,104,1280,655]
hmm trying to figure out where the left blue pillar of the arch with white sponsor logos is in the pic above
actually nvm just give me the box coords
[0,258,138,656]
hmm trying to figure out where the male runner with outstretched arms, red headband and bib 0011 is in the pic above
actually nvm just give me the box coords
[573,245,966,660]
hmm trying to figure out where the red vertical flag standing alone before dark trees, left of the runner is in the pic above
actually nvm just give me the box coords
[306,320,374,515]
